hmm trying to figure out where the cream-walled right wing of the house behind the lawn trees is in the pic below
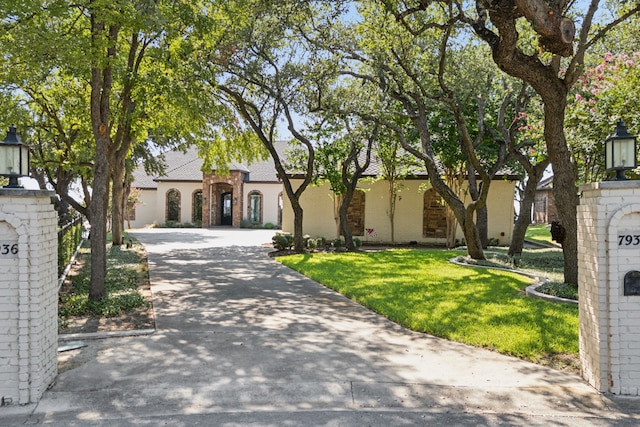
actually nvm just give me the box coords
[282,169,515,245]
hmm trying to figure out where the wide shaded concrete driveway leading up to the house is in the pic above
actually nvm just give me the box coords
[0,229,640,426]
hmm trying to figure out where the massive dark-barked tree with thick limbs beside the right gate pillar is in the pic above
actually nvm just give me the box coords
[384,0,640,284]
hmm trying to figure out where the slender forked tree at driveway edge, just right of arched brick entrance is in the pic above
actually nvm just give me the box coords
[192,1,344,251]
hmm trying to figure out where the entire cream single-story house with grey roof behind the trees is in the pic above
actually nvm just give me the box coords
[129,143,515,244]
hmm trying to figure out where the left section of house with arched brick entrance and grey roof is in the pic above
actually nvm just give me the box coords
[129,148,282,228]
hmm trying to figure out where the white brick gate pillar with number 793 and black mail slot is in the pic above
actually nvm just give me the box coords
[578,181,640,396]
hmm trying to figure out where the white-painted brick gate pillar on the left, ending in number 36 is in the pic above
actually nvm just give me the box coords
[0,188,58,405]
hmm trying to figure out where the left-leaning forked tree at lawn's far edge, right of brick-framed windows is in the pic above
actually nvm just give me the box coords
[340,4,506,259]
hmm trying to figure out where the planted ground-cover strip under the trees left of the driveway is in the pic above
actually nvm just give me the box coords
[58,236,147,327]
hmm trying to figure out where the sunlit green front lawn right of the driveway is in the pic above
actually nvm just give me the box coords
[278,250,578,370]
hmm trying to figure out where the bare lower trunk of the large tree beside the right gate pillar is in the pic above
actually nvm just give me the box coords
[544,102,578,285]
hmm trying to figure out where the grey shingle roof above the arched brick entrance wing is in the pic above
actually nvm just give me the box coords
[131,145,287,189]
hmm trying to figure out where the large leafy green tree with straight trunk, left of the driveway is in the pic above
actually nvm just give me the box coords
[0,0,228,300]
